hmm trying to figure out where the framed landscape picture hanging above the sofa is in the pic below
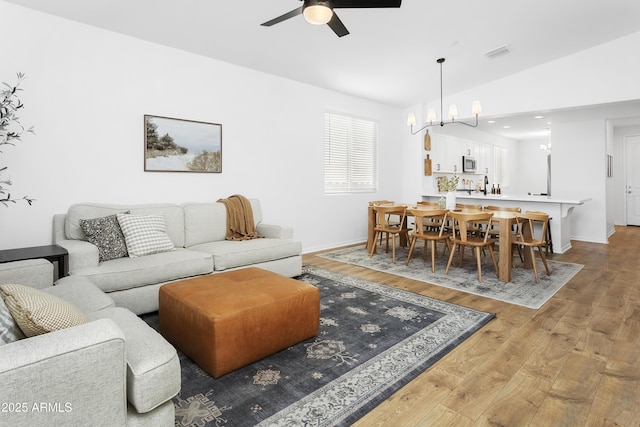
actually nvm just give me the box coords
[144,115,222,173]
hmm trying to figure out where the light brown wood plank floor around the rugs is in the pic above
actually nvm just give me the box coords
[303,227,640,427]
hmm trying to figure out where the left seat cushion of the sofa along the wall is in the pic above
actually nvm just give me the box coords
[73,248,213,292]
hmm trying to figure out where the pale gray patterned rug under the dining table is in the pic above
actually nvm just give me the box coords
[318,246,584,309]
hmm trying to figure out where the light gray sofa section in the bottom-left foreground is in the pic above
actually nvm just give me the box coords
[0,259,181,427]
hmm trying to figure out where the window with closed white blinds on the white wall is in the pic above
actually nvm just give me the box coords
[324,113,378,194]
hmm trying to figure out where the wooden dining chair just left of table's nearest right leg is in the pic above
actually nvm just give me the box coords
[444,212,498,282]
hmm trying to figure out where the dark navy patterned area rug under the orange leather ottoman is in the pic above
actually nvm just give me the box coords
[142,267,493,427]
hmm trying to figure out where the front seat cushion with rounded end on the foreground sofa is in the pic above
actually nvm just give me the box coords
[90,307,181,413]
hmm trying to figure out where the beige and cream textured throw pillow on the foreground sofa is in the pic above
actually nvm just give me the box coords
[0,285,89,337]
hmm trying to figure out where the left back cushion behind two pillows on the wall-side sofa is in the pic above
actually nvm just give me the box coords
[65,203,184,247]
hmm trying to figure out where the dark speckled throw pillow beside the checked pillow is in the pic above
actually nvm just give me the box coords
[80,212,128,261]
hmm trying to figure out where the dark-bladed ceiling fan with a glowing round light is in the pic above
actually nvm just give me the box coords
[260,0,402,37]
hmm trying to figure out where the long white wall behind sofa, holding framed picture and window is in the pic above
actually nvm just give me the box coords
[0,2,404,252]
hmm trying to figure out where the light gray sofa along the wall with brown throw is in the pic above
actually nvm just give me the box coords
[53,199,302,314]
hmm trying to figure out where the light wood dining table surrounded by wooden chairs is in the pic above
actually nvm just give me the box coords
[367,203,533,282]
